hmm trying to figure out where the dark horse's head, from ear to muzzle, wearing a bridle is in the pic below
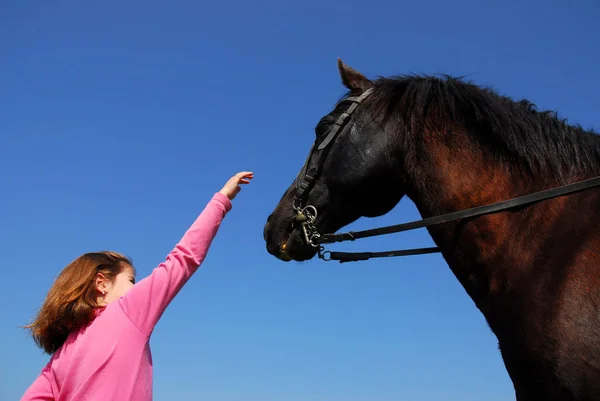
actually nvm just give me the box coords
[264,60,404,261]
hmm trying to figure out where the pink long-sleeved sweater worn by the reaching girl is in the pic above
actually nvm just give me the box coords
[21,193,232,401]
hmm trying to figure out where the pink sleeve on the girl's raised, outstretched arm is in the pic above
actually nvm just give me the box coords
[118,192,231,336]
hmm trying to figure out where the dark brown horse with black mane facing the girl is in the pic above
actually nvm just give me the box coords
[263,59,600,401]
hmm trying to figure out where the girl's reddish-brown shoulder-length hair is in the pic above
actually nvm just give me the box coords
[25,251,133,354]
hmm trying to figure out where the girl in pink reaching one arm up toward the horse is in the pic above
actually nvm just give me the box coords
[21,172,254,401]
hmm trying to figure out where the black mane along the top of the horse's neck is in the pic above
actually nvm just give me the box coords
[366,75,600,179]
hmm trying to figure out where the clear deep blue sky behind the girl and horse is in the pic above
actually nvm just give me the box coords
[0,0,600,401]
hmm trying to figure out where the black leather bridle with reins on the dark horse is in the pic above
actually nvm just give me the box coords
[293,88,600,263]
